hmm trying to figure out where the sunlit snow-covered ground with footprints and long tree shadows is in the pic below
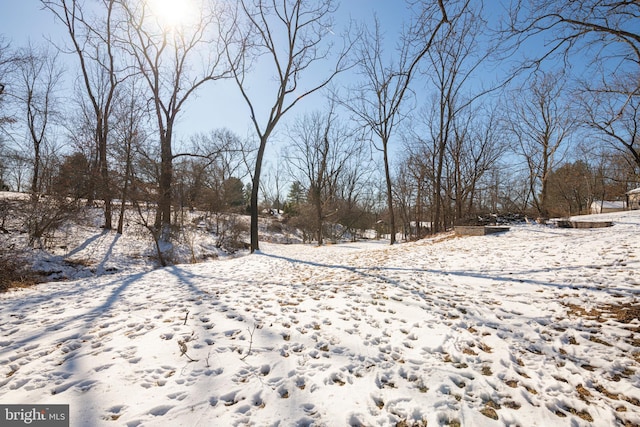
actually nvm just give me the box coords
[0,211,640,427]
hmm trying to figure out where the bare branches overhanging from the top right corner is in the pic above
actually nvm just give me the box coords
[504,0,640,179]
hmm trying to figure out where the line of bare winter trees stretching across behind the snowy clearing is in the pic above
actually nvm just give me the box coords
[0,0,640,251]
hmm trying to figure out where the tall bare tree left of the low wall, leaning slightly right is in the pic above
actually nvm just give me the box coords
[426,2,500,232]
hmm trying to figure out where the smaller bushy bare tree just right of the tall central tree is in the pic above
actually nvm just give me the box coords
[286,108,359,245]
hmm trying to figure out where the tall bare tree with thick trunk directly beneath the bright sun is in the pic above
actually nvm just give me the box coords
[119,0,229,242]
